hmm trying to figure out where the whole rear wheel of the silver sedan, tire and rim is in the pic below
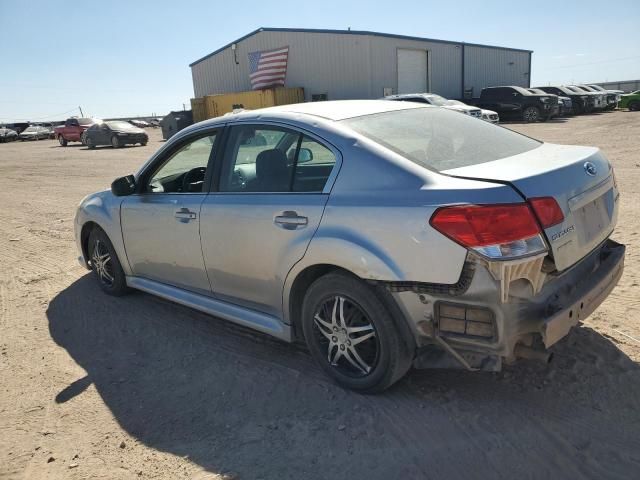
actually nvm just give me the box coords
[302,273,413,393]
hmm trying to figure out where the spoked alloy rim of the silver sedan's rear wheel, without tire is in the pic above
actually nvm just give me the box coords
[313,295,380,377]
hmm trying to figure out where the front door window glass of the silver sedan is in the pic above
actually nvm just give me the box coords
[145,133,216,193]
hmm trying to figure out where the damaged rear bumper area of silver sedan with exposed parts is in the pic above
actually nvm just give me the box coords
[388,240,625,371]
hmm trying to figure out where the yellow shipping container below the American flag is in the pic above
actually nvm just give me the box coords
[191,87,304,122]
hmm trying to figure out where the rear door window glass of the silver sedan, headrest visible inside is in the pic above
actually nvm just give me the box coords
[220,125,336,193]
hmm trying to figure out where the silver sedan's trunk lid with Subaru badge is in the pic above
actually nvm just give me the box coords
[442,143,618,270]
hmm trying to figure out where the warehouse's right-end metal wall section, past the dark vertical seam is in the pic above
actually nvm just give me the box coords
[464,45,531,97]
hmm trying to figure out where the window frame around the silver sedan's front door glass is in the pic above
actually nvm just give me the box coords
[133,125,225,196]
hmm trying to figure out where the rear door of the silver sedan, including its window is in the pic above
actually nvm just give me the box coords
[200,124,340,316]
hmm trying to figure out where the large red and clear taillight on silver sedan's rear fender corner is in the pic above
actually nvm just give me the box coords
[429,203,547,259]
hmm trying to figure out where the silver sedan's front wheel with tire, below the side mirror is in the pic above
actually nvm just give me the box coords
[87,227,129,297]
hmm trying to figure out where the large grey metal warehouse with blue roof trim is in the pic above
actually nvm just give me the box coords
[190,28,532,101]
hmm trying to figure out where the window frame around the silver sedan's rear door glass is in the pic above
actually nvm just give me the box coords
[209,119,342,195]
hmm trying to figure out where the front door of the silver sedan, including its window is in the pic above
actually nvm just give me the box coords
[120,131,218,295]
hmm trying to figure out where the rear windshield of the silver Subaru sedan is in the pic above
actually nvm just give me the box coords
[342,107,542,171]
